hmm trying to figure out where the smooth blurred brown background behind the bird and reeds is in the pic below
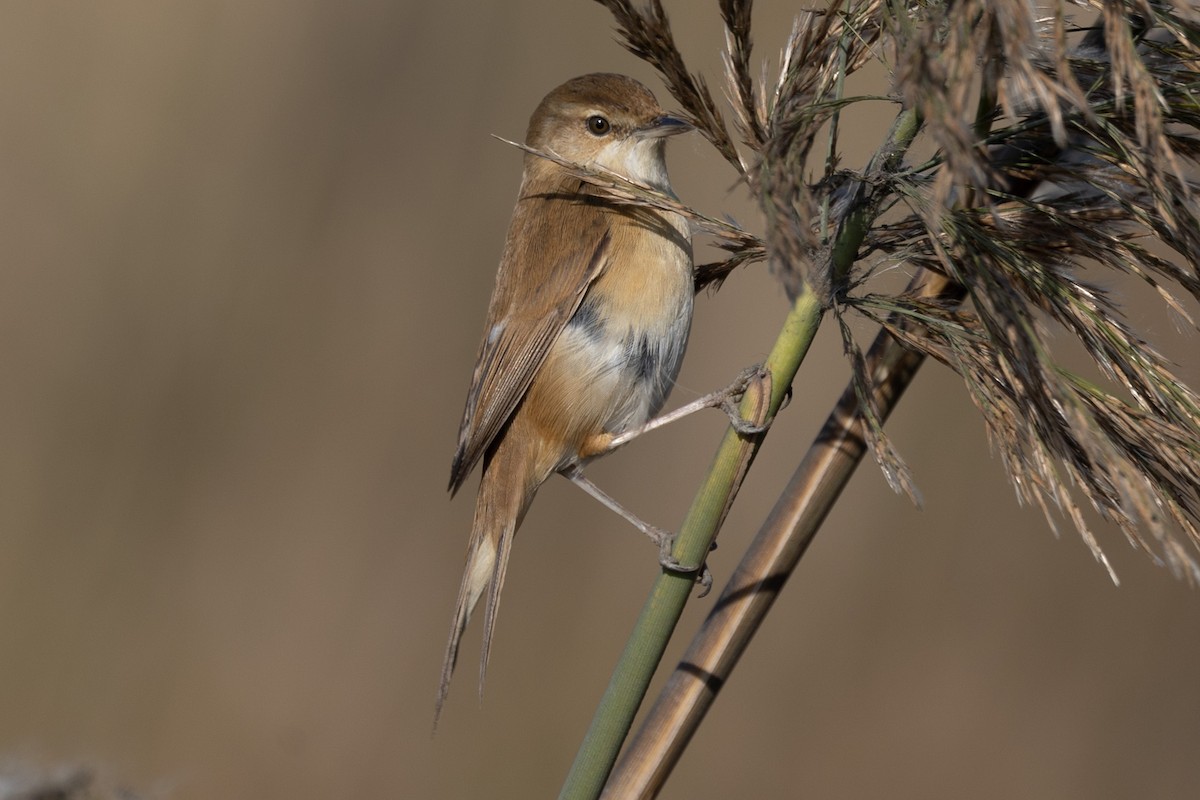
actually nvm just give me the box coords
[0,0,1200,800]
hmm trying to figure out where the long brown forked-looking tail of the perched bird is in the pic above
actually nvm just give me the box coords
[433,443,545,728]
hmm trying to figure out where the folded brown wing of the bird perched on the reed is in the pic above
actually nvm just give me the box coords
[450,182,611,493]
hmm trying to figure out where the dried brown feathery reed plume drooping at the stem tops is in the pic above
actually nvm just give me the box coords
[588,0,1200,582]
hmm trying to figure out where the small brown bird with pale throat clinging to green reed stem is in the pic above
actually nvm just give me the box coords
[437,74,712,714]
